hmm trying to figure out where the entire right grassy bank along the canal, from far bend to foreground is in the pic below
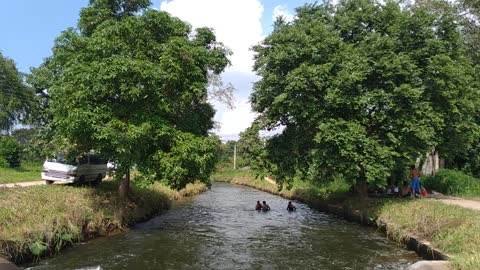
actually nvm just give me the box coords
[213,170,480,270]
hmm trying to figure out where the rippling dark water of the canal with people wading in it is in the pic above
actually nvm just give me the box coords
[24,183,419,270]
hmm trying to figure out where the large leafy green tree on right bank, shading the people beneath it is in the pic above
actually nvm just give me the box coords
[251,0,479,198]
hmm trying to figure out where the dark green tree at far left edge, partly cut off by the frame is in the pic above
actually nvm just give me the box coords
[0,53,34,132]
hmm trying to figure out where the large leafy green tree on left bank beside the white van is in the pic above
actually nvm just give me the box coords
[31,0,229,193]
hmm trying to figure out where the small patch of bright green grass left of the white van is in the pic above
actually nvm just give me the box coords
[0,161,43,184]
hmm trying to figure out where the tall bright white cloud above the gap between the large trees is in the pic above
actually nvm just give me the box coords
[160,0,263,72]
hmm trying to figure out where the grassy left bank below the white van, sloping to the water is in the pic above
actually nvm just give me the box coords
[0,181,207,264]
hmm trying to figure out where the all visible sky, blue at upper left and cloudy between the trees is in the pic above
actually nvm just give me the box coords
[0,0,314,138]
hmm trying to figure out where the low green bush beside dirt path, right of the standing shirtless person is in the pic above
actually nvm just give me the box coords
[422,169,480,196]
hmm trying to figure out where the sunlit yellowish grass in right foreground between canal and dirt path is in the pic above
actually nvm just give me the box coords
[377,199,480,270]
